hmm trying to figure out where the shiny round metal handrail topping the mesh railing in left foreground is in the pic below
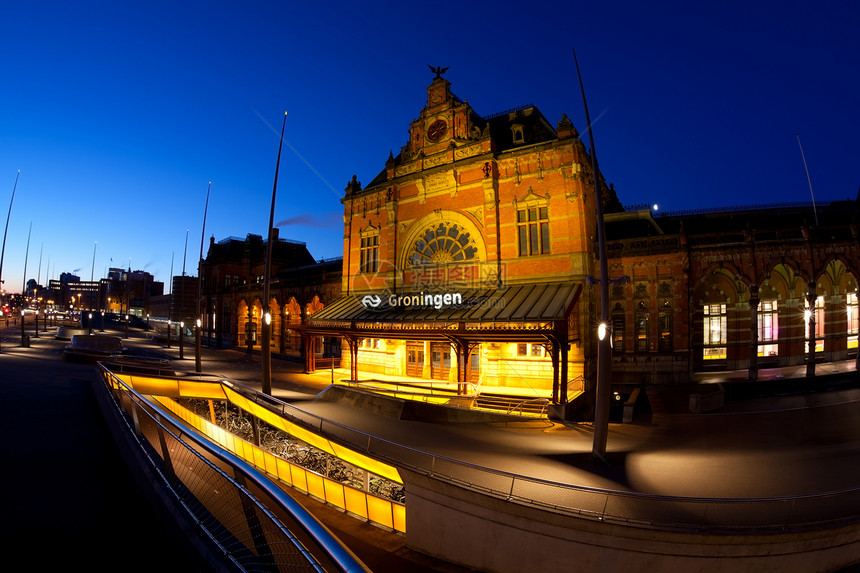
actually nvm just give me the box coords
[99,363,369,573]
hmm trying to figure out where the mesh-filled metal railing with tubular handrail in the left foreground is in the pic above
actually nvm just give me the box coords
[96,366,369,572]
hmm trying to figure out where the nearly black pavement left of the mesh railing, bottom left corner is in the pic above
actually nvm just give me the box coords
[0,332,205,571]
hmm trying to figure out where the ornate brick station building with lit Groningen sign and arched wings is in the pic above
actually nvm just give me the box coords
[204,72,860,412]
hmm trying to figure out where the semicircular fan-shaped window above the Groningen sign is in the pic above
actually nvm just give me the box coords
[397,209,487,270]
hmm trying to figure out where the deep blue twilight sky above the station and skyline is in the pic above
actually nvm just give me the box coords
[0,0,860,292]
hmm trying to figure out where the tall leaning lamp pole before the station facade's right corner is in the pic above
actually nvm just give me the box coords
[573,50,612,459]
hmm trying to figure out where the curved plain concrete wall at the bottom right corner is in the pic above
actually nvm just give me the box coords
[401,470,860,573]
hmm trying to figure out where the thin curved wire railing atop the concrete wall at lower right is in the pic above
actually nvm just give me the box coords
[227,383,860,533]
